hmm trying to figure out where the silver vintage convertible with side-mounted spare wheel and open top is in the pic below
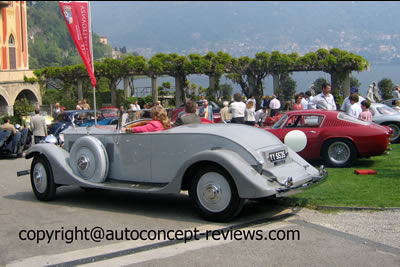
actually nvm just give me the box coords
[20,122,327,221]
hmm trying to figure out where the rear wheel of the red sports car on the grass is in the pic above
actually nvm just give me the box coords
[322,139,357,168]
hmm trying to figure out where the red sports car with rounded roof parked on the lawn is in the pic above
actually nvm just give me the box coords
[264,109,393,167]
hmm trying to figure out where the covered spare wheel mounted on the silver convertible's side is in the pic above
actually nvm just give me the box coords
[70,136,108,183]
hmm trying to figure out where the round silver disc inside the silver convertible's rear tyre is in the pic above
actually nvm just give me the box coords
[196,172,232,212]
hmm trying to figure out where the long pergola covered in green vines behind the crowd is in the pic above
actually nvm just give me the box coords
[35,48,369,106]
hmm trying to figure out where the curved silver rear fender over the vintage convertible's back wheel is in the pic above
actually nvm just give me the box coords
[166,149,276,198]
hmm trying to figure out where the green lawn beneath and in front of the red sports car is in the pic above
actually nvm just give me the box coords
[289,144,400,208]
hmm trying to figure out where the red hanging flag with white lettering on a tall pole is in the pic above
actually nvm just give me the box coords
[58,1,96,87]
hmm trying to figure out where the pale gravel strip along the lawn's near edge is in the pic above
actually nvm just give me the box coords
[297,208,400,248]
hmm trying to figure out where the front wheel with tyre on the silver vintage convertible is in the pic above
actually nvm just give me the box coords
[31,155,57,201]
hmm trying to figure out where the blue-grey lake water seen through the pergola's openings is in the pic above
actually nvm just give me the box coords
[123,65,400,97]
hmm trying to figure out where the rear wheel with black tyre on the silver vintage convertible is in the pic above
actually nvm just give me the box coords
[189,165,245,222]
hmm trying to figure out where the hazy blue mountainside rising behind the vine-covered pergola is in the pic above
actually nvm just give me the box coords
[91,1,400,62]
